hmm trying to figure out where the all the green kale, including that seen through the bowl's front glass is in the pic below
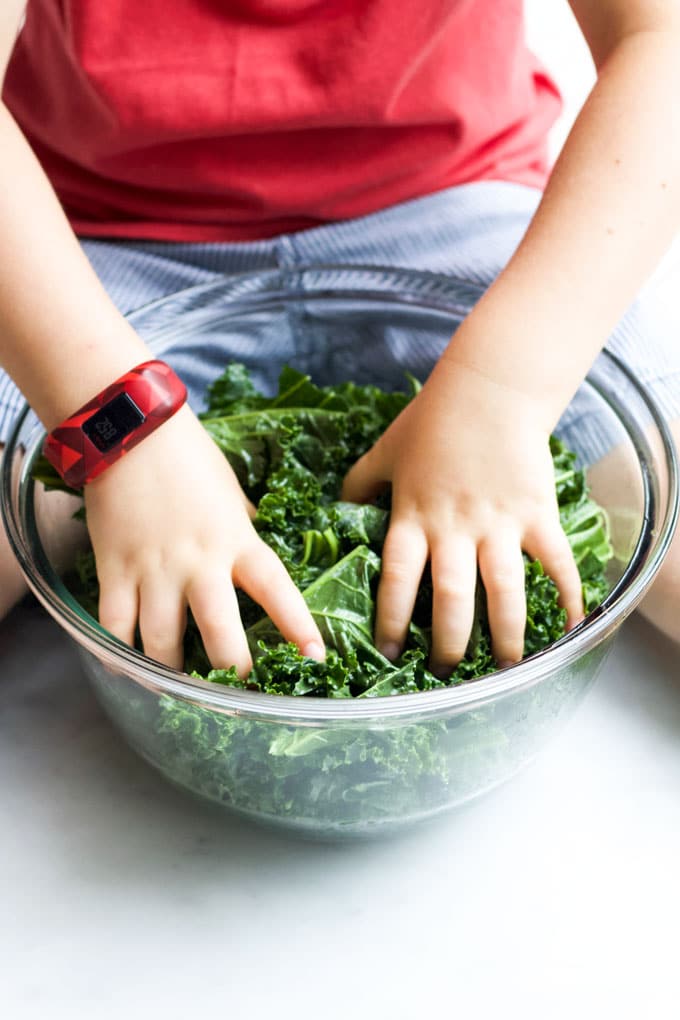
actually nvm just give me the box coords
[40,364,612,836]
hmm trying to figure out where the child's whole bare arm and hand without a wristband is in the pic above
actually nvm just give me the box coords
[344,0,680,675]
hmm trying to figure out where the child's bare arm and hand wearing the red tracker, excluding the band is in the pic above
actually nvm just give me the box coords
[0,13,324,675]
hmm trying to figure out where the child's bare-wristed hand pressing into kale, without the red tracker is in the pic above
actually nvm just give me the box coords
[343,360,583,675]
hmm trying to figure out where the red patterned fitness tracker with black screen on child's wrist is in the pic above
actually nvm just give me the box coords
[43,361,187,489]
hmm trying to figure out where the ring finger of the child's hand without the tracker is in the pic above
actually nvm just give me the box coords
[478,530,526,666]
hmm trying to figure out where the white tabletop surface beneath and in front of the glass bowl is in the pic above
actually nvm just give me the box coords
[0,606,680,1020]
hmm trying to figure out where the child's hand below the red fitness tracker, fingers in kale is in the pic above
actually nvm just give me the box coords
[85,407,324,676]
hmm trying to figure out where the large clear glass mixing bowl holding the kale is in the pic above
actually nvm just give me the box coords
[1,266,678,838]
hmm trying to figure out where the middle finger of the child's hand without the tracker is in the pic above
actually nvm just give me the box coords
[430,538,477,678]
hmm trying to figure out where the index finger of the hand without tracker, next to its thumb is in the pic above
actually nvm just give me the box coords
[375,520,428,660]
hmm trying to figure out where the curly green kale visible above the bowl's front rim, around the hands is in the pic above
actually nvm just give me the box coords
[57,364,612,698]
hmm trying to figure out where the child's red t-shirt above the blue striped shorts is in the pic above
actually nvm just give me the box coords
[3,0,560,241]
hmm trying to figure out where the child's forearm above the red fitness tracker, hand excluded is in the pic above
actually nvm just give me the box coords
[0,104,148,428]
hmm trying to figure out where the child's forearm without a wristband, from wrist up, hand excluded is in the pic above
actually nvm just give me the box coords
[444,23,680,427]
